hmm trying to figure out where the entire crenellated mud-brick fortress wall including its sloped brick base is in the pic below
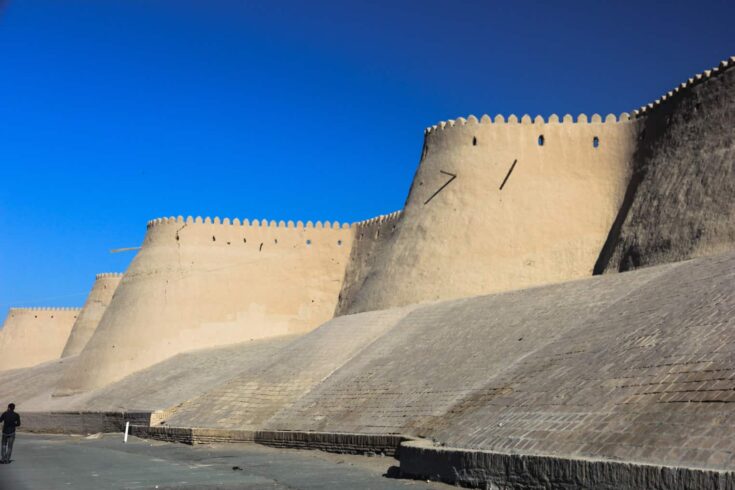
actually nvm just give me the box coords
[0,53,735,488]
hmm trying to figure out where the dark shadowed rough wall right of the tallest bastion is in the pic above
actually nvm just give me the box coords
[596,58,735,272]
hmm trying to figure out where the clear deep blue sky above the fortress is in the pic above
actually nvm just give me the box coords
[0,0,735,315]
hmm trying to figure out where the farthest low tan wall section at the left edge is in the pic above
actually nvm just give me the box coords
[0,308,80,371]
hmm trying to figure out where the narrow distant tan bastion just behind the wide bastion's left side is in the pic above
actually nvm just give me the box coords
[61,272,122,357]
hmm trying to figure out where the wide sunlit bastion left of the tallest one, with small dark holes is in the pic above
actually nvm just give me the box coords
[57,217,352,395]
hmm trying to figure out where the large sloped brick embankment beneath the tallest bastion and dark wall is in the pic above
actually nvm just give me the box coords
[158,254,735,488]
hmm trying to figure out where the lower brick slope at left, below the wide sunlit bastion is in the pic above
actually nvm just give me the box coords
[10,335,298,433]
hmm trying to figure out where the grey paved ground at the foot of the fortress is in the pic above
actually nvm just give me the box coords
[0,434,449,490]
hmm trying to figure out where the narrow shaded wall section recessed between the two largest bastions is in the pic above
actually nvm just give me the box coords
[335,211,401,315]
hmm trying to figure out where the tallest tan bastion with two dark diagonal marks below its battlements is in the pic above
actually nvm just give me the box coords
[340,116,636,313]
